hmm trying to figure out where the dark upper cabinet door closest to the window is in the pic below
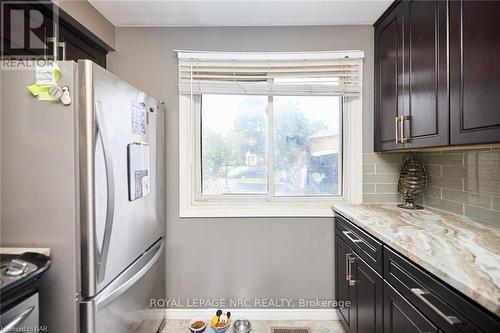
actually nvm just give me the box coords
[374,3,405,151]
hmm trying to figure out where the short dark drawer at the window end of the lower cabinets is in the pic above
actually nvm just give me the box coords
[335,213,383,275]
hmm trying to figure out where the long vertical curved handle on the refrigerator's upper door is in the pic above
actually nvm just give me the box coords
[95,101,115,282]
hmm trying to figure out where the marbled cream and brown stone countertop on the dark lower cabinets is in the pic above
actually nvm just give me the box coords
[332,204,500,316]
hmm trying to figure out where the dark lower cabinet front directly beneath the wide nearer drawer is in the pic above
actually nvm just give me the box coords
[384,281,439,333]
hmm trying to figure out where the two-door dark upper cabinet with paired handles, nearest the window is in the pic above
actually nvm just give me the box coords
[375,0,449,151]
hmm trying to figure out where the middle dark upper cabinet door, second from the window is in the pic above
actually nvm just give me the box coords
[400,0,449,148]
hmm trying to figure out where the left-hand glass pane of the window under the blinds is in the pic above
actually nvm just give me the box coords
[201,95,268,194]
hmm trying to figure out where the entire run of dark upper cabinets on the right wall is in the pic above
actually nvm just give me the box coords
[374,0,500,151]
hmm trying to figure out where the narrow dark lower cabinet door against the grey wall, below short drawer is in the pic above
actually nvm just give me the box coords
[335,236,356,333]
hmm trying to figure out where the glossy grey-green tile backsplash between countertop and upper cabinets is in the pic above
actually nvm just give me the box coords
[363,148,500,223]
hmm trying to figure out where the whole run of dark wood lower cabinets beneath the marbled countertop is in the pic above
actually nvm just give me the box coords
[335,215,500,333]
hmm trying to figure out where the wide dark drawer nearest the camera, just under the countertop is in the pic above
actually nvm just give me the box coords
[384,246,500,332]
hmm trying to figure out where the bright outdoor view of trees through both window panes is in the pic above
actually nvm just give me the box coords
[201,95,342,196]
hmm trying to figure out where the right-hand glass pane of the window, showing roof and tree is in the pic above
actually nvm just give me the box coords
[273,96,342,196]
